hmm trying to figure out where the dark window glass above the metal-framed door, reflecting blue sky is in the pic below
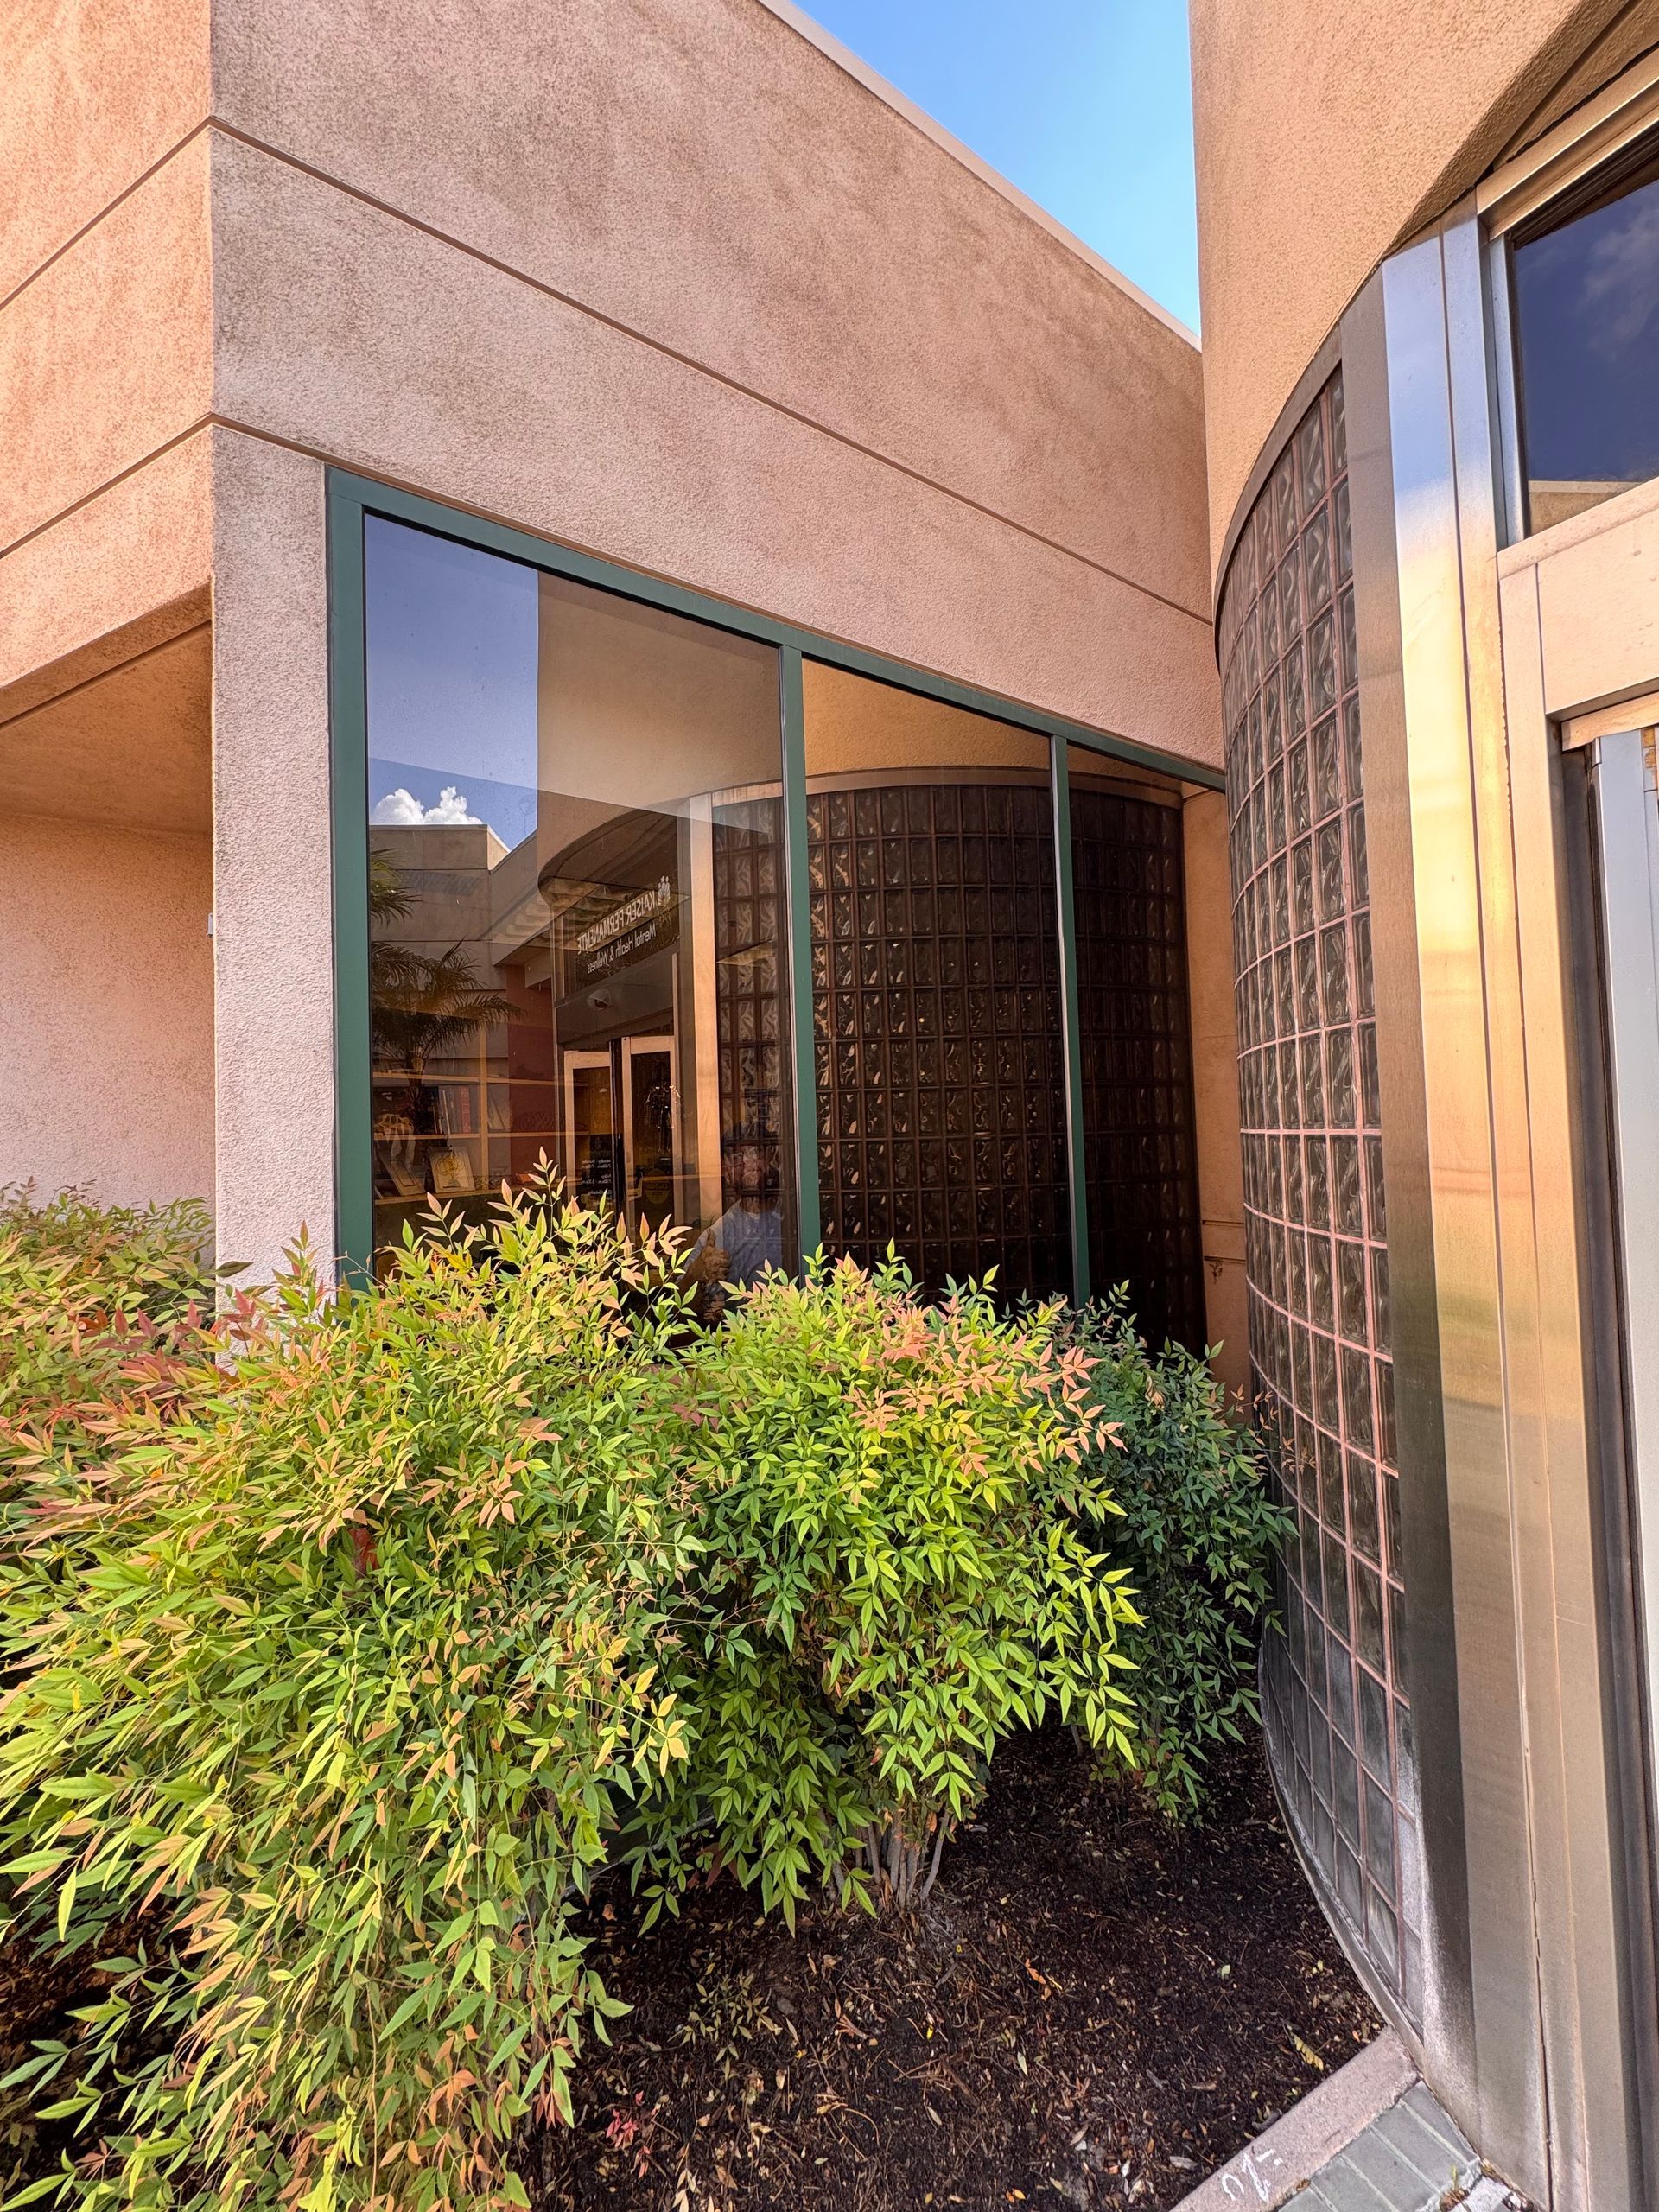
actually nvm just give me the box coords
[1513,139,1659,531]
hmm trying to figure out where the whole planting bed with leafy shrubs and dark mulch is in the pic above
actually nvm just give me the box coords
[0,1179,1327,2212]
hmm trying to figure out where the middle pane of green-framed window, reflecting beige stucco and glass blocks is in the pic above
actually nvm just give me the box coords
[805,661,1071,1296]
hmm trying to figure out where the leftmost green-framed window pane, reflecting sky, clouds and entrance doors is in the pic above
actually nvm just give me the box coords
[365,518,797,1281]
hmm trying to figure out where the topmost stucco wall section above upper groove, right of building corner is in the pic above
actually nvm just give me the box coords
[214,0,1204,645]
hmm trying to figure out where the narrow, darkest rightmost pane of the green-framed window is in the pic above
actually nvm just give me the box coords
[1066,746,1204,1351]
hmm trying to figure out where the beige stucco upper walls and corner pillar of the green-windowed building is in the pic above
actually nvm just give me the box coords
[0,0,1219,1265]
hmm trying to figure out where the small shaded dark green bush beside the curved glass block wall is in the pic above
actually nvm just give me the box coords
[1068,1299,1294,1818]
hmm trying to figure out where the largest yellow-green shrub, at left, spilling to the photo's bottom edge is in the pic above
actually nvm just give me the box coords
[0,1201,695,2212]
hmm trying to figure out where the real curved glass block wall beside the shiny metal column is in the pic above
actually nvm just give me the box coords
[1221,372,1422,2022]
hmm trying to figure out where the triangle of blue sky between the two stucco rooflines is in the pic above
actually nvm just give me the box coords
[803,0,1199,329]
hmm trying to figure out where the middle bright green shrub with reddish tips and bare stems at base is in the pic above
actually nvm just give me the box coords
[635,1261,1133,1913]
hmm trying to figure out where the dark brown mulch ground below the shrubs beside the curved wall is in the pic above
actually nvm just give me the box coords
[524,1730,1378,2212]
